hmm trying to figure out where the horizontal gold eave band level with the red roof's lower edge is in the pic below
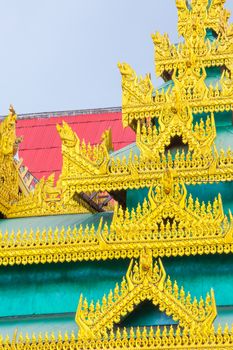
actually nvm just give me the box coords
[57,145,233,193]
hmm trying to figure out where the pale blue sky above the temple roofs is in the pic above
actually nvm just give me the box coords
[0,0,233,115]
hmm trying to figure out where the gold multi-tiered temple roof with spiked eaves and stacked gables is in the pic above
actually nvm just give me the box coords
[0,0,233,349]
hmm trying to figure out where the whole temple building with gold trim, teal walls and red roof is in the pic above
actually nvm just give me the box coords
[0,0,233,350]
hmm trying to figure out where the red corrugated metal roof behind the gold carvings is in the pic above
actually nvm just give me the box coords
[17,112,135,179]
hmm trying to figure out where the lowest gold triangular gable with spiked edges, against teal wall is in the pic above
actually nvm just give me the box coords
[75,251,217,338]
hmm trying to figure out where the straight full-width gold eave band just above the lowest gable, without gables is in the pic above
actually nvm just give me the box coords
[0,221,233,266]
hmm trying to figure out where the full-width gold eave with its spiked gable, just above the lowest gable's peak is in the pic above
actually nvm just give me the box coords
[0,176,233,265]
